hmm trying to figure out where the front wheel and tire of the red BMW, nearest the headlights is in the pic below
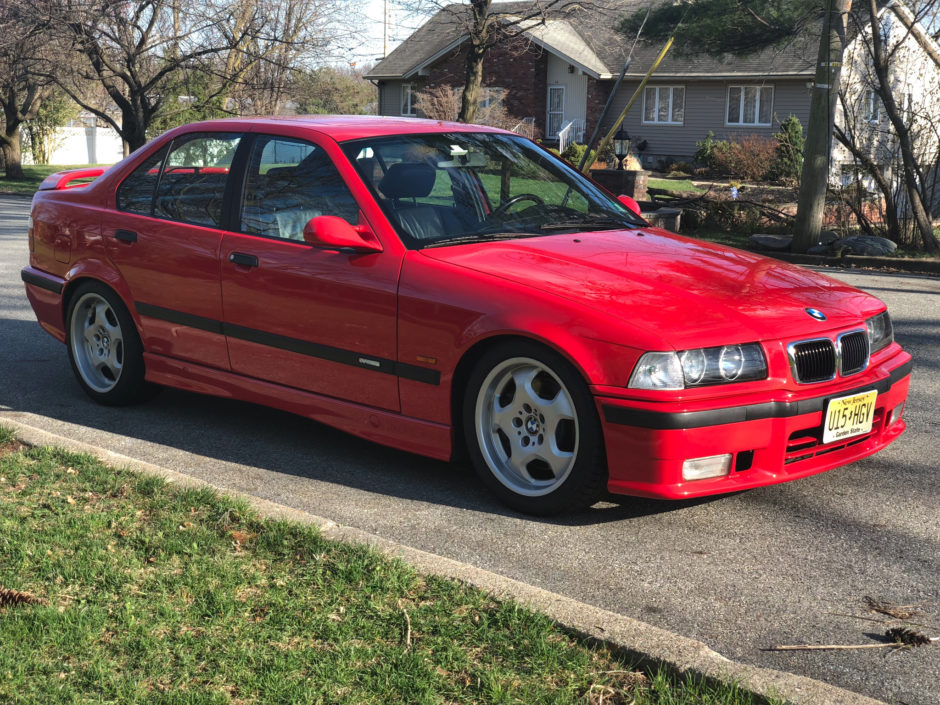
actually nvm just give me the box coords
[463,341,607,515]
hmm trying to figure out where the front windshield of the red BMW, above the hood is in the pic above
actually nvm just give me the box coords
[342,132,643,249]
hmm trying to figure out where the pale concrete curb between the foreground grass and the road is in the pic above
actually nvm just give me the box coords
[0,415,885,705]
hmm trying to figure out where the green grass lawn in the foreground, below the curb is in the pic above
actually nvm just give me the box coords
[0,429,780,705]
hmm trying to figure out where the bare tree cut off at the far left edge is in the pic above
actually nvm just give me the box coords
[0,3,52,179]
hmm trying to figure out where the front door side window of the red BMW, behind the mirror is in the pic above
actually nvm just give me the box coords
[241,135,359,241]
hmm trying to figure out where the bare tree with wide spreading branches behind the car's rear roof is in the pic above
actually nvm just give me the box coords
[38,0,346,153]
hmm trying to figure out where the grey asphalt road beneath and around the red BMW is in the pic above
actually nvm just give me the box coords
[0,197,940,705]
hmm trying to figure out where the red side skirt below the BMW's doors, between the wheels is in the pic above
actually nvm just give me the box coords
[144,353,453,460]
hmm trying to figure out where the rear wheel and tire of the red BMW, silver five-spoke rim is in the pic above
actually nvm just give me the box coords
[66,282,148,406]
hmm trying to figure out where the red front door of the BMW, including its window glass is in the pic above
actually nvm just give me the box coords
[220,135,401,411]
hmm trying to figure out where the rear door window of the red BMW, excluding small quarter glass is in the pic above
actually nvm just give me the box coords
[153,133,241,228]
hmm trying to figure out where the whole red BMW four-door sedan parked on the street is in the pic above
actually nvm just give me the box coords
[22,117,911,514]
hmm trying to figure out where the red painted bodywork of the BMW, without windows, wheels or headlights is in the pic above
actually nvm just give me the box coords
[23,118,911,512]
